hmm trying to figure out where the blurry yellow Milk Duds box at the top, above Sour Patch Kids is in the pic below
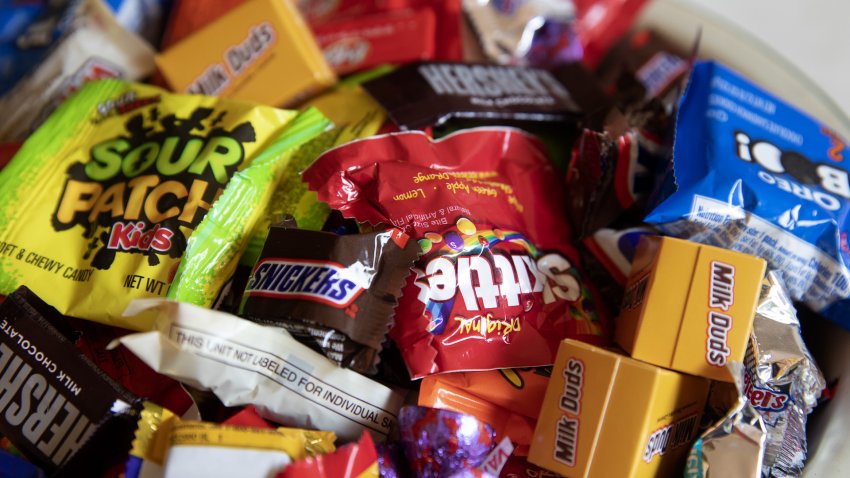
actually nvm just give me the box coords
[156,0,336,106]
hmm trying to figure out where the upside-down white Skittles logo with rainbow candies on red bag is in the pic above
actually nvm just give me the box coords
[414,217,582,345]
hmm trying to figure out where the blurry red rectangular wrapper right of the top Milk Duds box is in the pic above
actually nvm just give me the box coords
[313,9,436,75]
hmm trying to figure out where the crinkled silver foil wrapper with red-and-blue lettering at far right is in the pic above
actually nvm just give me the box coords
[744,272,826,477]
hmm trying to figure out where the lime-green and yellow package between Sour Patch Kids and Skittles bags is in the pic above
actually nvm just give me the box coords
[168,70,386,307]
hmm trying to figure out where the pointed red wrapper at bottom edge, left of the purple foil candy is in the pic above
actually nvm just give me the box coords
[276,432,378,478]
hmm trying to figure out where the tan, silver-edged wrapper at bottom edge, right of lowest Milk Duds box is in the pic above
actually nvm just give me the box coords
[684,362,767,478]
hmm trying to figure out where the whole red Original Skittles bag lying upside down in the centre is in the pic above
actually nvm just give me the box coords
[302,128,608,378]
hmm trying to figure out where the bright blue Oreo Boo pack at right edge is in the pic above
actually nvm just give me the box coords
[646,62,850,328]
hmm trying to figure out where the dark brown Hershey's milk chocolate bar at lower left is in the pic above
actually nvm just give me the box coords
[0,287,140,477]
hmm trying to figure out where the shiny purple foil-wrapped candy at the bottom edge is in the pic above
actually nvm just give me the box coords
[398,406,496,478]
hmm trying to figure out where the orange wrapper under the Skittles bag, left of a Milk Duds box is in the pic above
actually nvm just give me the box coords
[419,367,551,456]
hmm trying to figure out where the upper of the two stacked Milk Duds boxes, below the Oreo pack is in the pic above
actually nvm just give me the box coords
[614,236,765,382]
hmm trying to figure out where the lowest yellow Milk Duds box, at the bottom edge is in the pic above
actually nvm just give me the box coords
[528,339,709,478]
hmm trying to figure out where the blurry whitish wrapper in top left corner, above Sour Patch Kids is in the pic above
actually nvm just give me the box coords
[0,0,154,141]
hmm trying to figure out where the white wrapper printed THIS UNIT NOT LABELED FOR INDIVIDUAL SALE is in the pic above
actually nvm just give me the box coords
[113,299,403,441]
